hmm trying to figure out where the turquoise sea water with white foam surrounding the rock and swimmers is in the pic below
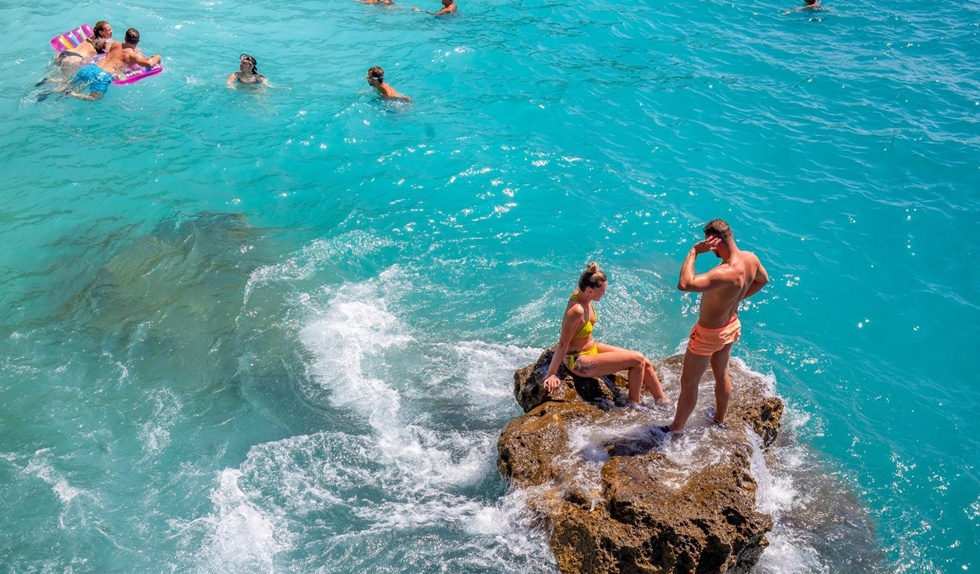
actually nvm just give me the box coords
[0,0,980,573]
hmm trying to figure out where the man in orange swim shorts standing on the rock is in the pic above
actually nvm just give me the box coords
[660,219,769,432]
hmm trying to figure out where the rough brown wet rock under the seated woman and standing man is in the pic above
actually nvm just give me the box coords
[497,351,782,573]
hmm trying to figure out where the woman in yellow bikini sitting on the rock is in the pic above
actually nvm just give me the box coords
[544,263,667,404]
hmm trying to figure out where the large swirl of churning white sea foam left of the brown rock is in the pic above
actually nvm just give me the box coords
[191,267,552,572]
